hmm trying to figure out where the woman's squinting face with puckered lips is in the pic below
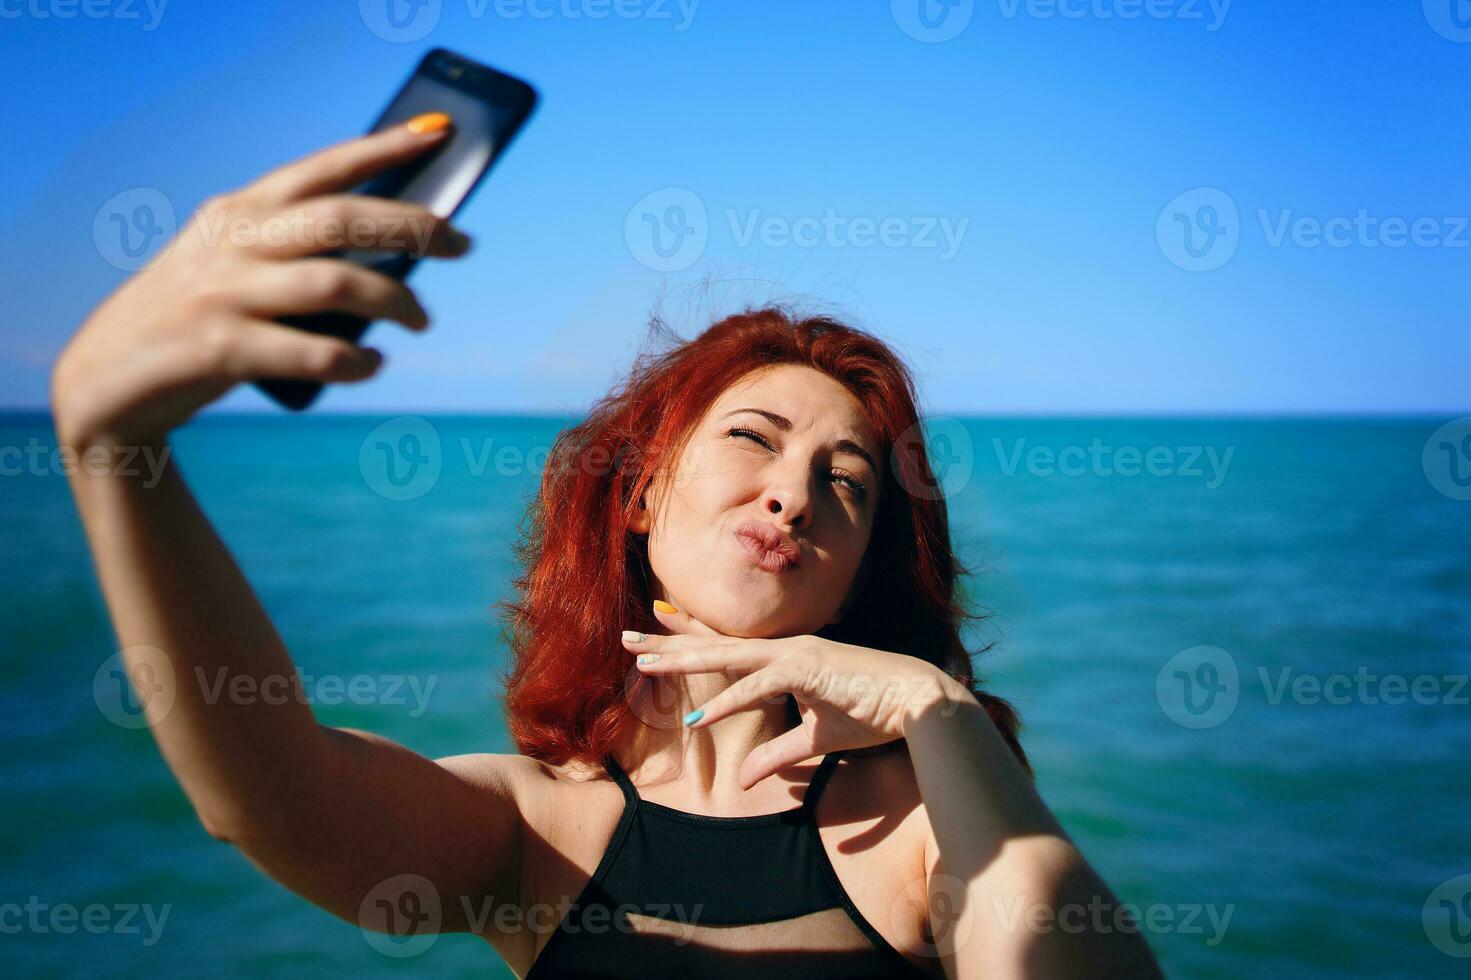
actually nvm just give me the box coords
[631,365,883,637]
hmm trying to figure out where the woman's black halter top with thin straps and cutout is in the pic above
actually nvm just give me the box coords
[525,752,928,980]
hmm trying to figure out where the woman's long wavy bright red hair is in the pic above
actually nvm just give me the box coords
[497,306,1030,771]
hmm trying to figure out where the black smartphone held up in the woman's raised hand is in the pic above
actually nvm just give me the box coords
[256,47,537,412]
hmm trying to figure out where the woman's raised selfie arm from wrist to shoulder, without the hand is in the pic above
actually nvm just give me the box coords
[71,443,521,931]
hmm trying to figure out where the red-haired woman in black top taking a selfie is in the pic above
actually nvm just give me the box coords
[51,115,1158,977]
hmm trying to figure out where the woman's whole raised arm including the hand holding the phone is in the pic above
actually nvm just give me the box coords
[51,116,535,952]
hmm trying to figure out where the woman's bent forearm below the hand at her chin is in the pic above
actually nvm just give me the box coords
[905,675,1162,980]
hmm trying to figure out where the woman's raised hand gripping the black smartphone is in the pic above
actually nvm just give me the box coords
[51,70,529,449]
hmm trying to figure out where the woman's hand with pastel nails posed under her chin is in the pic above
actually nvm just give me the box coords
[624,606,975,789]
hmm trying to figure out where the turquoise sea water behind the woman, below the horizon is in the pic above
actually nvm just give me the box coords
[0,416,1471,979]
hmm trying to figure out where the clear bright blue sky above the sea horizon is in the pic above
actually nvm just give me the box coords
[0,0,1471,413]
